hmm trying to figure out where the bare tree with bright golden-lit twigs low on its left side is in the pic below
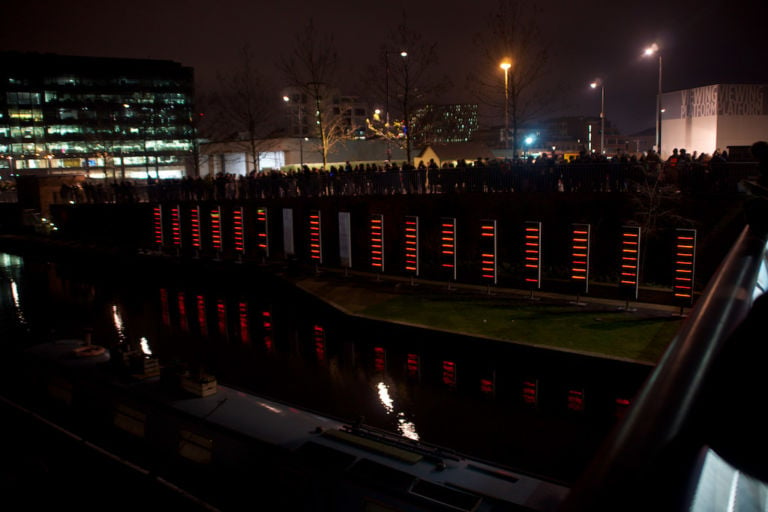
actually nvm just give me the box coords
[368,13,451,163]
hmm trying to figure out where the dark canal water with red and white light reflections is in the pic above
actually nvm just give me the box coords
[0,254,649,483]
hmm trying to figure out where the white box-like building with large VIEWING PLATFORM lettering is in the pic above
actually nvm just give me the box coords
[661,84,768,157]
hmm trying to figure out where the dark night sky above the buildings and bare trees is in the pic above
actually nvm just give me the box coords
[0,0,768,134]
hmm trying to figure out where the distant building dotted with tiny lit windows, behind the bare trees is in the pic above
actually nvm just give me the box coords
[410,103,478,148]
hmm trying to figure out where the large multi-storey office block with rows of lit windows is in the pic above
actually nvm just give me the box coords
[0,52,195,179]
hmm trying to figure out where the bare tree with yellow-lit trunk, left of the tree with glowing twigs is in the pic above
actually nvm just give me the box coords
[278,19,352,168]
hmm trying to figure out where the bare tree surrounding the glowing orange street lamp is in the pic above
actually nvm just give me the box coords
[468,0,555,154]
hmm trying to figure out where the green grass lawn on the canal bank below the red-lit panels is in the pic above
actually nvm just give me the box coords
[358,295,682,363]
